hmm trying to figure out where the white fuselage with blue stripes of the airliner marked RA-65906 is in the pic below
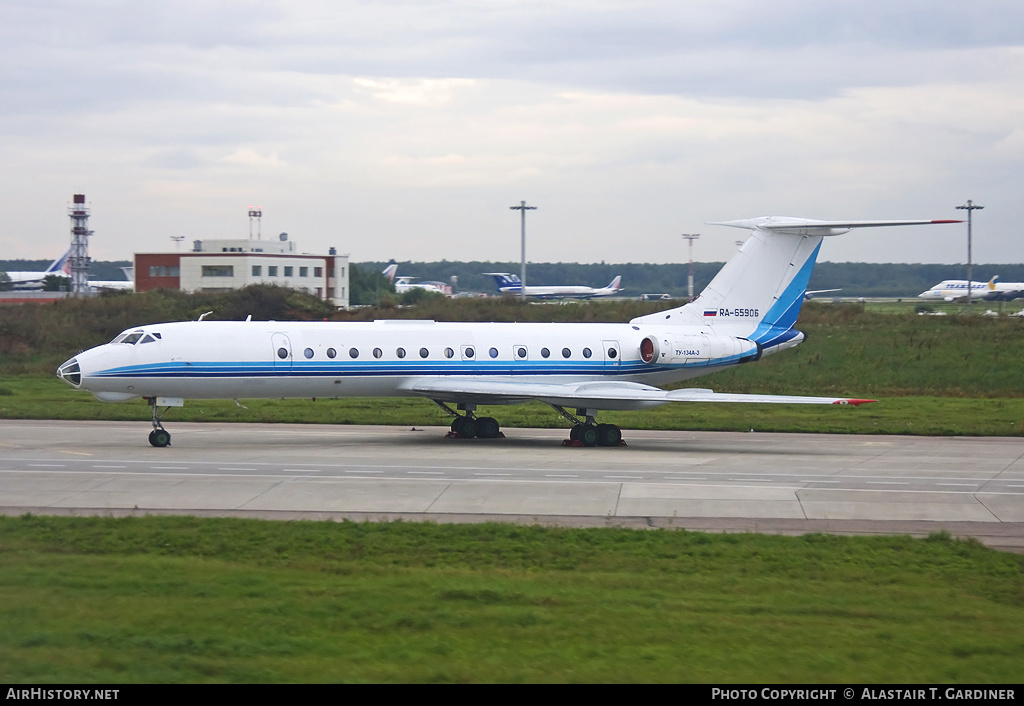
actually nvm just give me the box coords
[60,321,770,409]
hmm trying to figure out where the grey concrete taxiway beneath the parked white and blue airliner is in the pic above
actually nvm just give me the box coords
[0,420,1024,551]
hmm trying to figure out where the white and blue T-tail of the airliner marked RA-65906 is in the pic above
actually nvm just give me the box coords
[631,217,962,348]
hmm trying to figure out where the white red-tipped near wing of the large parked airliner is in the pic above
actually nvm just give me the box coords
[406,377,874,410]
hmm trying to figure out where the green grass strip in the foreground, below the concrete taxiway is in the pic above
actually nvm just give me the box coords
[0,516,1024,683]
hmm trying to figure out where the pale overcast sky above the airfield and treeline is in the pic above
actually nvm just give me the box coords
[0,0,1024,264]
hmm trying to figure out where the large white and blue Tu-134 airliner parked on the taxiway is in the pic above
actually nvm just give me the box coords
[57,217,961,447]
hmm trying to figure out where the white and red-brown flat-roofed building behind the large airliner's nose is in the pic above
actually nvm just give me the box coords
[135,233,349,308]
